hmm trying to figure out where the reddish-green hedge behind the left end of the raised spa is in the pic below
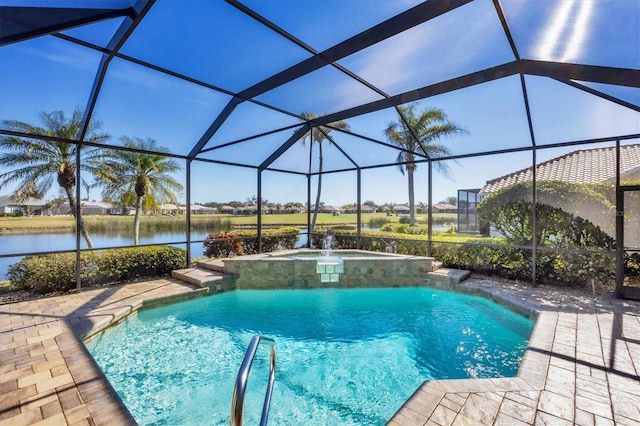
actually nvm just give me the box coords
[203,227,300,257]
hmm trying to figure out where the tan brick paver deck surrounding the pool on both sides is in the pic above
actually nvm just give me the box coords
[0,279,640,426]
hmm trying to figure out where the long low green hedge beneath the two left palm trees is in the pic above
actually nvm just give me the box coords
[7,246,187,294]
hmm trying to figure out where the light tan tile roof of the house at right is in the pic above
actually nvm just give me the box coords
[480,144,640,194]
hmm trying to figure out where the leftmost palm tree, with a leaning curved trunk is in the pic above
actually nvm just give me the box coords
[0,109,110,248]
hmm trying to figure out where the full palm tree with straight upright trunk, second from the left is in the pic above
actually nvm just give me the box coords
[96,136,183,245]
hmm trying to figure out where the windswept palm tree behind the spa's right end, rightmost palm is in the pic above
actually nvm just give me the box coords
[384,104,465,225]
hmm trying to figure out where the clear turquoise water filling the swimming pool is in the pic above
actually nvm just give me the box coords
[87,288,533,425]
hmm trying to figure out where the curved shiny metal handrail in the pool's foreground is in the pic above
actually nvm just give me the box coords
[231,336,276,426]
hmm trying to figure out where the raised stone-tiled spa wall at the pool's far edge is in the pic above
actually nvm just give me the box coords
[224,250,433,290]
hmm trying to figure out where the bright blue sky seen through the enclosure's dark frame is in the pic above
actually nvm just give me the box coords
[0,0,640,205]
